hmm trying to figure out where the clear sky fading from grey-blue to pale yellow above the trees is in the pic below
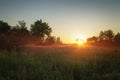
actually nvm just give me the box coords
[0,0,120,43]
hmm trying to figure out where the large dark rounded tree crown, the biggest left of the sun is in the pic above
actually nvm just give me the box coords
[31,20,52,38]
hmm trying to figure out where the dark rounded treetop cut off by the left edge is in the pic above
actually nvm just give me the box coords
[0,21,11,34]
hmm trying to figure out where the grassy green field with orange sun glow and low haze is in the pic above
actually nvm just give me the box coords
[0,46,120,80]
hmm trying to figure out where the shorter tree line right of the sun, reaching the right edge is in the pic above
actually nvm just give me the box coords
[87,29,120,47]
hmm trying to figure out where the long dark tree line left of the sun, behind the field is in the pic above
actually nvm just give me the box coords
[0,20,62,49]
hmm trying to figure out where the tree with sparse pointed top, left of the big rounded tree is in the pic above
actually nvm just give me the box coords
[10,20,30,46]
